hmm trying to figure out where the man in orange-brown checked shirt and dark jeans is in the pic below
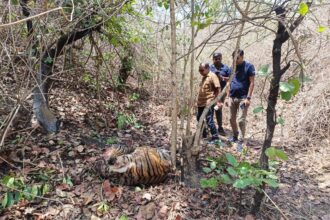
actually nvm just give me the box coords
[197,63,220,143]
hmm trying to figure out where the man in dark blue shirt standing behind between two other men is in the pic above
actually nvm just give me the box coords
[210,52,230,136]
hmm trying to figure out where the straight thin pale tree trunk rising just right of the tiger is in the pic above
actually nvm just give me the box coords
[170,0,178,169]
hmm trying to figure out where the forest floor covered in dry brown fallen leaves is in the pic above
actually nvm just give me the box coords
[0,77,330,220]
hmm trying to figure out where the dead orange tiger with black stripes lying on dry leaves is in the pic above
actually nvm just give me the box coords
[96,146,171,185]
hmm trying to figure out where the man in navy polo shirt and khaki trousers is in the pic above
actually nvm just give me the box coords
[225,49,255,151]
